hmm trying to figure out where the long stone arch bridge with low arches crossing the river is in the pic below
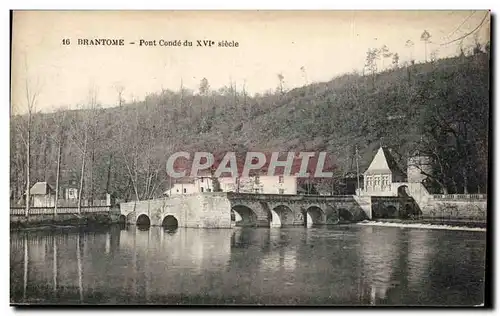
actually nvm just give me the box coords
[120,192,412,228]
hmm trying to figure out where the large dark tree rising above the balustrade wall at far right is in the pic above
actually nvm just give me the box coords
[415,55,489,194]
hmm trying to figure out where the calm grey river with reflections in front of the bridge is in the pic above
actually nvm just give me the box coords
[10,224,486,305]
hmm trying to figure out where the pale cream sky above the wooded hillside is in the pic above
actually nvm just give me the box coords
[11,11,489,113]
